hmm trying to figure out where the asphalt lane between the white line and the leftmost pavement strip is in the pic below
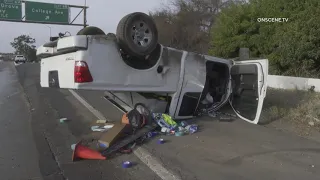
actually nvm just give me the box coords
[16,64,160,180]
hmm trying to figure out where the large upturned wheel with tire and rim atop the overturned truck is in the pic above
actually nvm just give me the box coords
[116,12,158,57]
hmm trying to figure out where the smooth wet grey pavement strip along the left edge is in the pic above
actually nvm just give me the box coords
[0,62,42,180]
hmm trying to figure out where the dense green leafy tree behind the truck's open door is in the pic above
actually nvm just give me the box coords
[209,0,320,77]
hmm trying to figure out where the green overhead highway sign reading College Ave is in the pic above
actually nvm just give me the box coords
[25,1,70,23]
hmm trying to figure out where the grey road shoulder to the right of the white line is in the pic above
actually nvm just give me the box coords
[78,90,320,180]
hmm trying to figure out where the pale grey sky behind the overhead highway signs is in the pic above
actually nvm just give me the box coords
[0,0,166,53]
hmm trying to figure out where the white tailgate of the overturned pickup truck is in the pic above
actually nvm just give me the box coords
[40,52,76,89]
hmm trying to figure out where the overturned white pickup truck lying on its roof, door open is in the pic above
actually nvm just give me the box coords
[37,13,268,124]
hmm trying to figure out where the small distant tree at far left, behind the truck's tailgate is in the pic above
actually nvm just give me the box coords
[10,35,37,61]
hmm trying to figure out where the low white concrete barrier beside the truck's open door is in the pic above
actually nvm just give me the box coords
[268,75,320,92]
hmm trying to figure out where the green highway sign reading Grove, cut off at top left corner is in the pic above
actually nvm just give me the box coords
[0,0,22,20]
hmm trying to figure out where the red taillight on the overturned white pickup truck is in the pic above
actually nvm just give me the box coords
[74,61,93,83]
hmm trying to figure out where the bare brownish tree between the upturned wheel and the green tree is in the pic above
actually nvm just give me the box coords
[150,0,238,53]
